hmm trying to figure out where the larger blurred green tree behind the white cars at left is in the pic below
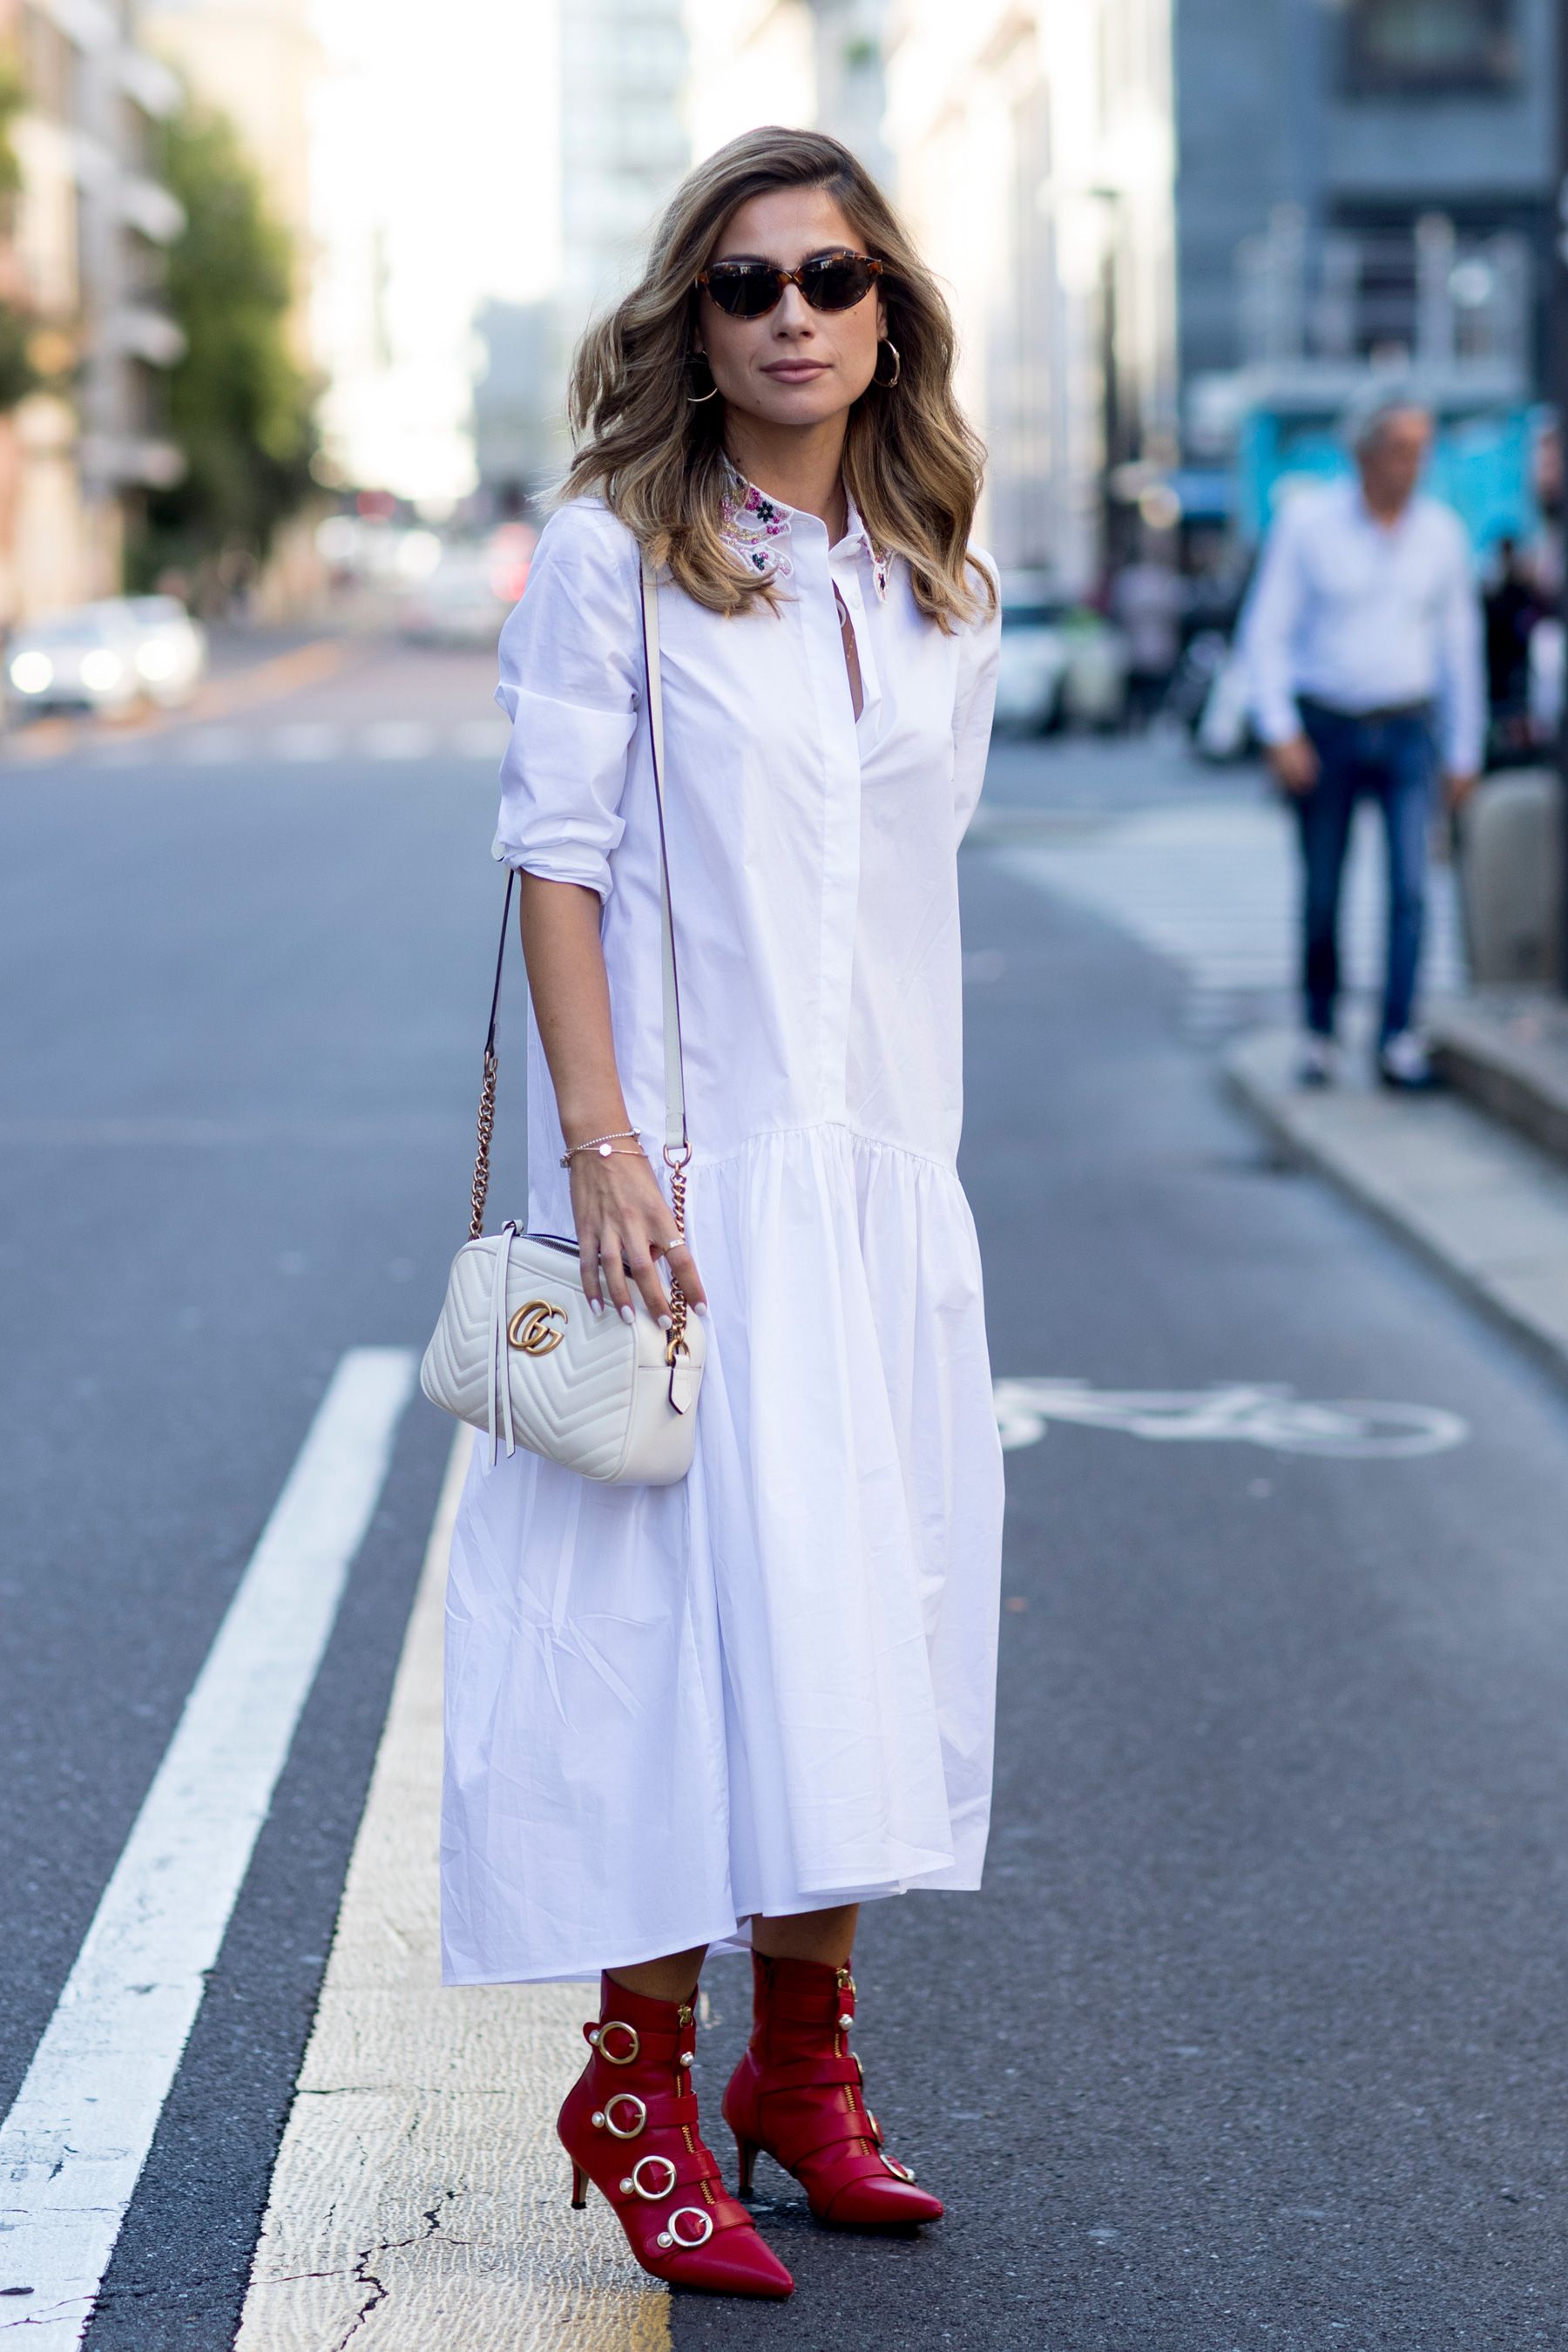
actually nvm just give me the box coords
[134,98,315,592]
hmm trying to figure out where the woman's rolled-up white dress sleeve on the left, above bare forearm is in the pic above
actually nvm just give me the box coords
[494,501,642,898]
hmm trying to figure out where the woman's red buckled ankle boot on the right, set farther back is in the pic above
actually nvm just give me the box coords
[724,1952,943,2230]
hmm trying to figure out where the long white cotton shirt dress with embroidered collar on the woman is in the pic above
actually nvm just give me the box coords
[442,487,1002,1985]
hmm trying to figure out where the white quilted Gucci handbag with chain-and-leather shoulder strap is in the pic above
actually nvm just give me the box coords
[418,562,703,1486]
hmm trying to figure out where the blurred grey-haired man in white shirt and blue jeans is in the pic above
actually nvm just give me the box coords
[1244,393,1486,1086]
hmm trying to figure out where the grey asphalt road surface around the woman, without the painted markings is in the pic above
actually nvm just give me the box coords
[0,652,1568,2352]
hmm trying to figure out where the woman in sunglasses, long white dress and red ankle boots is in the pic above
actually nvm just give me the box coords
[442,130,1002,2295]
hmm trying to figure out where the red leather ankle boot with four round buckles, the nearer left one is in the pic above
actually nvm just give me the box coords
[555,1976,794,2295]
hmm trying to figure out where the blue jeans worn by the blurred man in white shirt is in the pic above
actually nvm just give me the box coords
[1295,703,1436,1044]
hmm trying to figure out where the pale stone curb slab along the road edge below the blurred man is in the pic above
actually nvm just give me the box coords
[1222,1031,1568,1385]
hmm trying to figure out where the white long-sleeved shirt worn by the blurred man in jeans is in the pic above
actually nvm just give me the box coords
[1241,483,1486,776]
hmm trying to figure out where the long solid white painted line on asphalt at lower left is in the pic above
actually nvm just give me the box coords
[0,1348,414,2352]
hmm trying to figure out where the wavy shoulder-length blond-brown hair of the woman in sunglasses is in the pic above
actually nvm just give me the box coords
[562,127,997,631]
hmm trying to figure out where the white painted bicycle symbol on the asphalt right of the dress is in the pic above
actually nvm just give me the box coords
[995,1381,1470,1461]
